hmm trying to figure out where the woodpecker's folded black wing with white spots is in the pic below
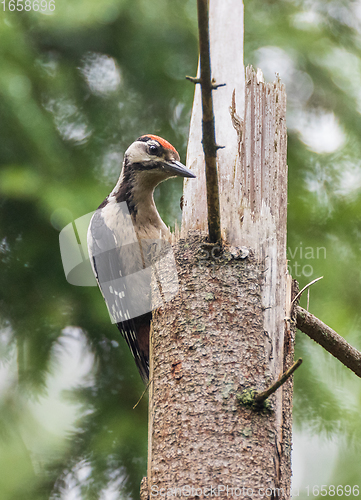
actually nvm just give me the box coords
[88,204,152,383]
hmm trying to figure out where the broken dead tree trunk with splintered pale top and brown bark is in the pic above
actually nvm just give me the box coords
[142,0,294,500]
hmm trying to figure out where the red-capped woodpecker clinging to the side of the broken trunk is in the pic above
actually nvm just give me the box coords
[88,134,195,383]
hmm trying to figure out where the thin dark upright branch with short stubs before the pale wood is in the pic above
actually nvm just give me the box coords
[194,0,221,243]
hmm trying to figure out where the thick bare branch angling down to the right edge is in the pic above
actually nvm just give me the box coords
[296,306,361,377]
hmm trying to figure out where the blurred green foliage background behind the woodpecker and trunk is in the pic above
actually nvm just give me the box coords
[0,0,361,500]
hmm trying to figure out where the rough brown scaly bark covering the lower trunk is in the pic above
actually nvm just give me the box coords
[149,234,290,498]
